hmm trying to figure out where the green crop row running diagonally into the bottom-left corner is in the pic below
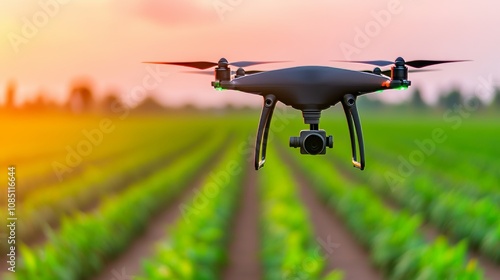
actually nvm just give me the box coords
[6,129,224,280]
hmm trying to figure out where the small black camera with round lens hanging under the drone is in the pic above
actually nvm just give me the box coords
[290,129,333,155]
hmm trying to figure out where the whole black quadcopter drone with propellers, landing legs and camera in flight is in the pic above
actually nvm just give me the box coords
[146,57,466,170]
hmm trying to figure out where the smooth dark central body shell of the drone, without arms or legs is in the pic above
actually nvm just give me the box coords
[227,66,391,110]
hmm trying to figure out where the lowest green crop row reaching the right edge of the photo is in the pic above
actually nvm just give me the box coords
[342,145,500,262]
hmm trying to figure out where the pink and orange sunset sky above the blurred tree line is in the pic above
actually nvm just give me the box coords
[0,0,500,106]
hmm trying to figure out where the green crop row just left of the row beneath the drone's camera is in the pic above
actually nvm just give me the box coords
[136,138,244,280]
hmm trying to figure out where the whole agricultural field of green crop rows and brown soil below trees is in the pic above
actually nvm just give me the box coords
[0,107,500,280]
